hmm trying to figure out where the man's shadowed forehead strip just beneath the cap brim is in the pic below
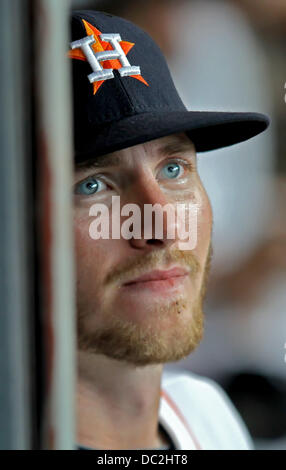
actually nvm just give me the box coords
[76,132,196,171]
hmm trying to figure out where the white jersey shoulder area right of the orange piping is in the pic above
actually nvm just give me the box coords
[162,370,253,450]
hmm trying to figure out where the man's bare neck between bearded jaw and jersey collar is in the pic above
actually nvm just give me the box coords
[77,351,166,449]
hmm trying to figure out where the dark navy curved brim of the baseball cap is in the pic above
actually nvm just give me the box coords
[75,111,270,162]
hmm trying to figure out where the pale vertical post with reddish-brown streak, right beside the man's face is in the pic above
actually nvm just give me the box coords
[34,0,76,449]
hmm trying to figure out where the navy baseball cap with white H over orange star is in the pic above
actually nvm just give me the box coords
[68,10,269,163]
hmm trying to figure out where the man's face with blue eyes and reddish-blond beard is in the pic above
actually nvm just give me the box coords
[74,134,212,365]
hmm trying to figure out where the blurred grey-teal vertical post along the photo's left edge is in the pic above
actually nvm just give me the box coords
[0,0,32,450]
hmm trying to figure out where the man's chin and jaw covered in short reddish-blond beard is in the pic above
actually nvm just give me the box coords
[78,300,204,366]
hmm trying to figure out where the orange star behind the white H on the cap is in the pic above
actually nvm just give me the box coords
[68,20,149,95]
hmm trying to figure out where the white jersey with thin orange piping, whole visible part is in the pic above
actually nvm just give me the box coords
[159,371,253,450]
